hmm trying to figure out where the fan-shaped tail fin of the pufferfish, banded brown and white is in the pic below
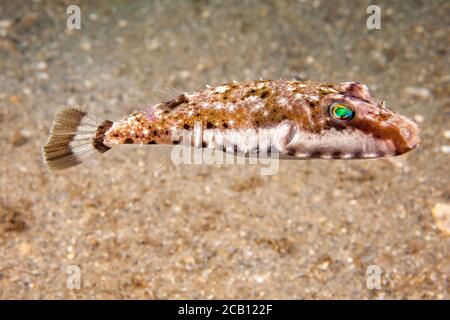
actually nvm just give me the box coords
[42,108,112,170]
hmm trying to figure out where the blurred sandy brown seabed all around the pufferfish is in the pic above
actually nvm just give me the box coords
[0,0,450,299]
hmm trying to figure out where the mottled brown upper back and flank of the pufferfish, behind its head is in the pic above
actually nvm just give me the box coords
[104,81,342,144]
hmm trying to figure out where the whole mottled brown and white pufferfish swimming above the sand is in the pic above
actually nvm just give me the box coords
[43,80,420,170]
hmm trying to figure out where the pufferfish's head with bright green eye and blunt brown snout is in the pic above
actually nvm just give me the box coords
[312,82,420,159]
